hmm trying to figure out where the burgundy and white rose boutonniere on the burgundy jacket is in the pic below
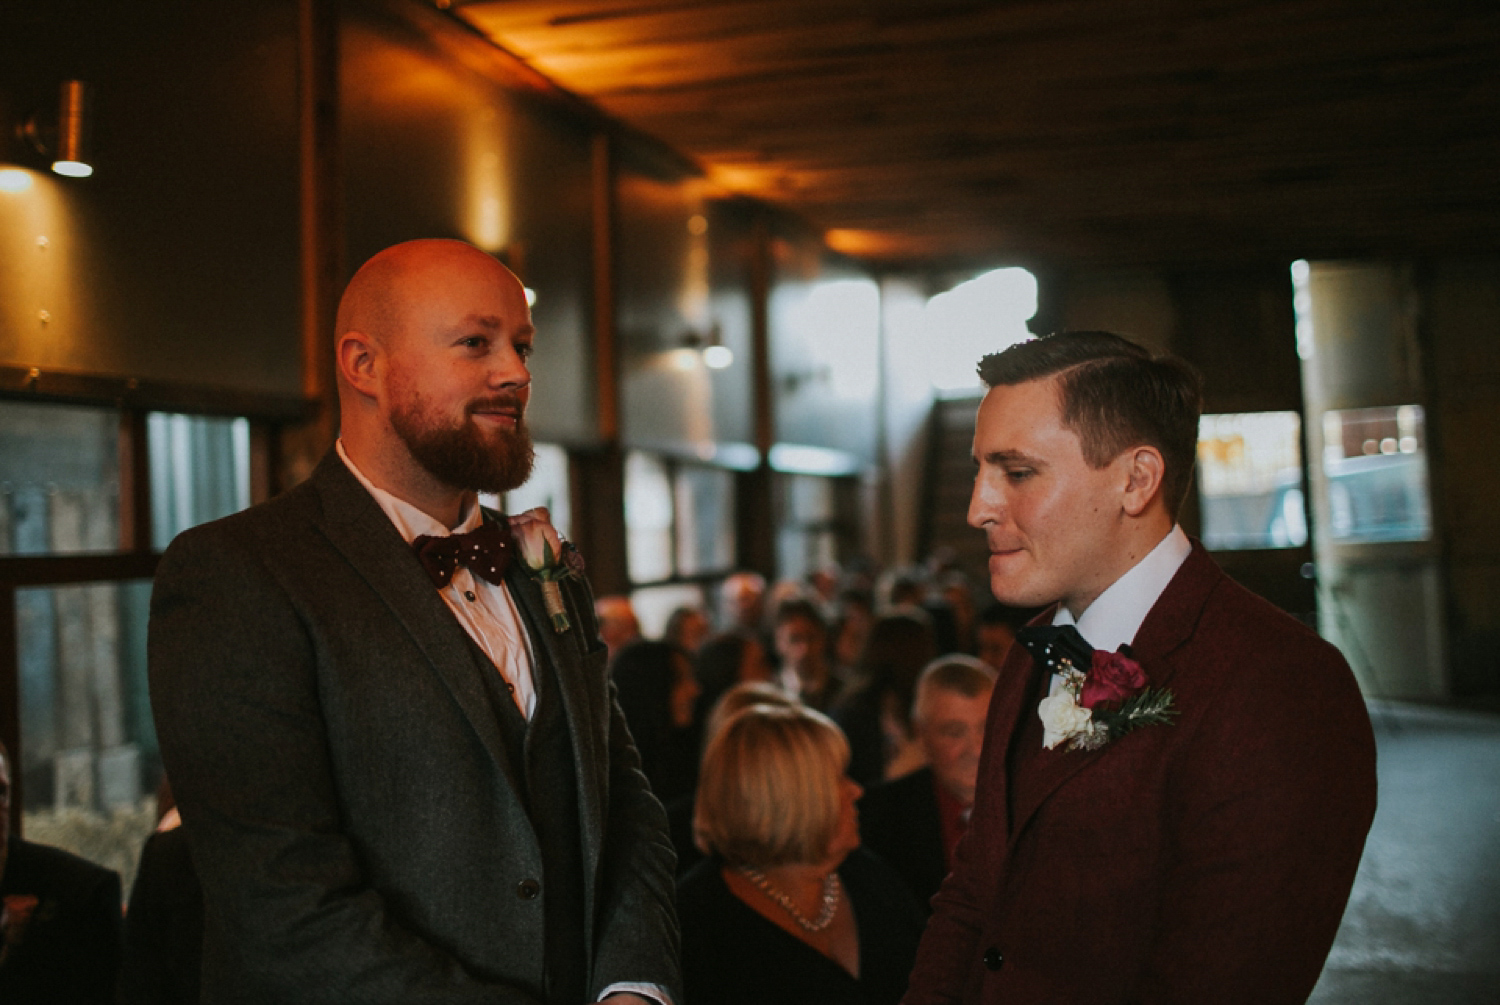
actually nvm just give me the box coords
[1037,647,1178,750]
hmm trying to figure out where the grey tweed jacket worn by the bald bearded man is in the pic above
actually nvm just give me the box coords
[149,452,681,1005]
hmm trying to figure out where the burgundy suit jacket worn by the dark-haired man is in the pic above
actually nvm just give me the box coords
[903,543,1376,1005]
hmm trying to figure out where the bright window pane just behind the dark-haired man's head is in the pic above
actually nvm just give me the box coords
[1199,413,1308,551]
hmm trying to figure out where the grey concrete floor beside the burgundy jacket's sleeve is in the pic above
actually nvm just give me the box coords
[1310,704,1500,1005]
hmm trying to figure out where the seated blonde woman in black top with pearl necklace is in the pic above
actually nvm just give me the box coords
[678,705,923,1005]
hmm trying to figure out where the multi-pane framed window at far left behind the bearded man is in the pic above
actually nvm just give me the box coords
[0,401,261,890]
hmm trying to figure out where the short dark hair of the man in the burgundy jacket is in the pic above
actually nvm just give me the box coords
[980,332,1203,519]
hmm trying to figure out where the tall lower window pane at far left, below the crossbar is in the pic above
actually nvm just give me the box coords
[15,581,162,891]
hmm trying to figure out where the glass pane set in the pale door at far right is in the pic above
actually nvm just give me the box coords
[1323,405,1433,543]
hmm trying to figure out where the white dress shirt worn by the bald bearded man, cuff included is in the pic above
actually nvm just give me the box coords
[335,440,672,1005]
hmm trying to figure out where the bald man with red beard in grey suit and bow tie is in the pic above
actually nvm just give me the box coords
[150,242,680,1005]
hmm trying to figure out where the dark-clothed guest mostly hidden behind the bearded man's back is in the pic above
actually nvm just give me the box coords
[119,779,203,1005]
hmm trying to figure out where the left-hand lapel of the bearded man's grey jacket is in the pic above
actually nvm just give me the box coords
[312,450,521,792]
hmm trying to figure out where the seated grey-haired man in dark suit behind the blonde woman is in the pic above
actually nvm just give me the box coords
[860,656,995,906]
